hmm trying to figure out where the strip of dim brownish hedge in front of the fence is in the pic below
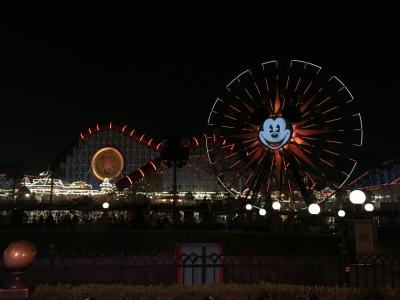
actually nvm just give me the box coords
[30,283,400,300]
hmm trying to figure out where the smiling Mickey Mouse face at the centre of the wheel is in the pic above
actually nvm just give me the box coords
[258,117,292,150]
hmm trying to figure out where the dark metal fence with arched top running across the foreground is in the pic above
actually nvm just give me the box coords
[0,253,400,288]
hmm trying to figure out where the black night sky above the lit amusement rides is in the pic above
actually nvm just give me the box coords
[0,1,400,172]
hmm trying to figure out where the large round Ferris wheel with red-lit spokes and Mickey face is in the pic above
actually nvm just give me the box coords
[206,60,363,206]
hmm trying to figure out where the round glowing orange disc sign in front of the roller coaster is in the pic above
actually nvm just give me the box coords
[91,147,124,180]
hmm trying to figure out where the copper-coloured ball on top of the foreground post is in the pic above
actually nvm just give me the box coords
[3,240,36,270]
